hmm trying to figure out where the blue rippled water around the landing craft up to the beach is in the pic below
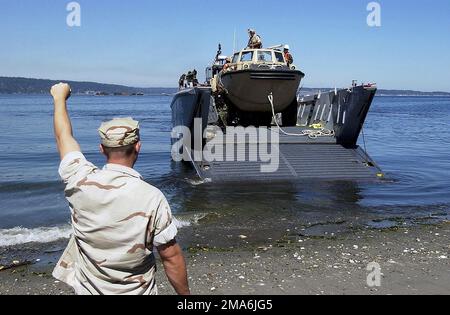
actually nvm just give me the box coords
[0,95,450,246]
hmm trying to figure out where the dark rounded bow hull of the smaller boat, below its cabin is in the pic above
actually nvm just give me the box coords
[220,69,304,113]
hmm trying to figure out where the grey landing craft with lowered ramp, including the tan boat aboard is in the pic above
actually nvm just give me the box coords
[171,46,384,182]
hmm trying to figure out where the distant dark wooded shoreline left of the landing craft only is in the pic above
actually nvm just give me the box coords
[0,77,176,95]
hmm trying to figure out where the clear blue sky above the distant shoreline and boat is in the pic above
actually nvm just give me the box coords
[0,0,450,92]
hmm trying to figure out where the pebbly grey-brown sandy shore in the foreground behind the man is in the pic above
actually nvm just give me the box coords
[0,222,450,295]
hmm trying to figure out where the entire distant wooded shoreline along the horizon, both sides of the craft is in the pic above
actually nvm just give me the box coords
[0,77,450,96]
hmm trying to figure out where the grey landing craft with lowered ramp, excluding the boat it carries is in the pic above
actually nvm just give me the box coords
[172,85,384,182]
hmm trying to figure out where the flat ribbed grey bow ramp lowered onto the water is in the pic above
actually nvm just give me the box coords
[194,128,383,182]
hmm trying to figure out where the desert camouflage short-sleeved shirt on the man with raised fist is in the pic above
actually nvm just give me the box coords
[53,152,177,295]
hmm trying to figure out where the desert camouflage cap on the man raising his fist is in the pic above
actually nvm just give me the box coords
[98,118,140,148]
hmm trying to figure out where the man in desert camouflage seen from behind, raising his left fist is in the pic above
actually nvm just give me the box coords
[51,83,190,295]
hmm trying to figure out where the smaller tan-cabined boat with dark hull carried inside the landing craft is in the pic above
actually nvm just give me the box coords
[207,44,305,126]
